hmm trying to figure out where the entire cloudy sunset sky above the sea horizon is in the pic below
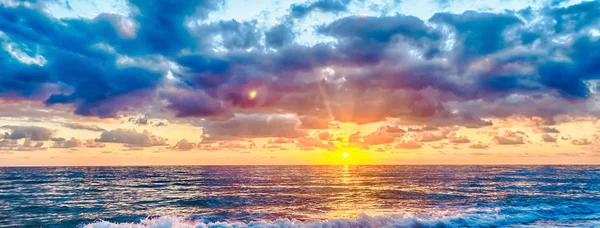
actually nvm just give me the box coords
[0,0,600,166]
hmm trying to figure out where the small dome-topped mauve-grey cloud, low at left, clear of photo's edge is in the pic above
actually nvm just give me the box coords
[96,128,167,147]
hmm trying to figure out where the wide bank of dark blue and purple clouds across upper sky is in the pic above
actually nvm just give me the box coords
[0,0,600,128]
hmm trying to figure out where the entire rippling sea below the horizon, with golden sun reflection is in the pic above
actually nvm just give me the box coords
[0,166,600,228]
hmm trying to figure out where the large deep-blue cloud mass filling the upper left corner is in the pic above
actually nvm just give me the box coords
[0,1,218,117]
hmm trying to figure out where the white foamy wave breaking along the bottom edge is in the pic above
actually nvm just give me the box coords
[83,208,600,228]
